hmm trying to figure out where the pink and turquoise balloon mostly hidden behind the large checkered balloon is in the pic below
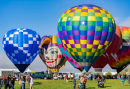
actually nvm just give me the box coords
[57,33,84,71]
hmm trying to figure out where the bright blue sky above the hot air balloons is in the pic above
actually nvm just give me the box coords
[0,0,130,72]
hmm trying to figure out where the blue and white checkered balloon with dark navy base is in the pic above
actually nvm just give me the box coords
[3,28,40,72]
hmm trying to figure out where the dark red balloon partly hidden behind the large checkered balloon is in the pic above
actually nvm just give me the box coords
[92,25,122,72]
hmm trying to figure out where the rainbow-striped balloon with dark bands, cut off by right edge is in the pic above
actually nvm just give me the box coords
[109,27,130,73]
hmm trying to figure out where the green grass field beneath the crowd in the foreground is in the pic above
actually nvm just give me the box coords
[2,79,130,89]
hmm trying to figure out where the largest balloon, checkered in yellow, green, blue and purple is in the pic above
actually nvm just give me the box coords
[58,4,116,71]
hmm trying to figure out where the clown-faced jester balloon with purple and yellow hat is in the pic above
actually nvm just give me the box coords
[39,35,66,72]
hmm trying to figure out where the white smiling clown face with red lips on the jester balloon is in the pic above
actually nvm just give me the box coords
[42,46,62,67]
